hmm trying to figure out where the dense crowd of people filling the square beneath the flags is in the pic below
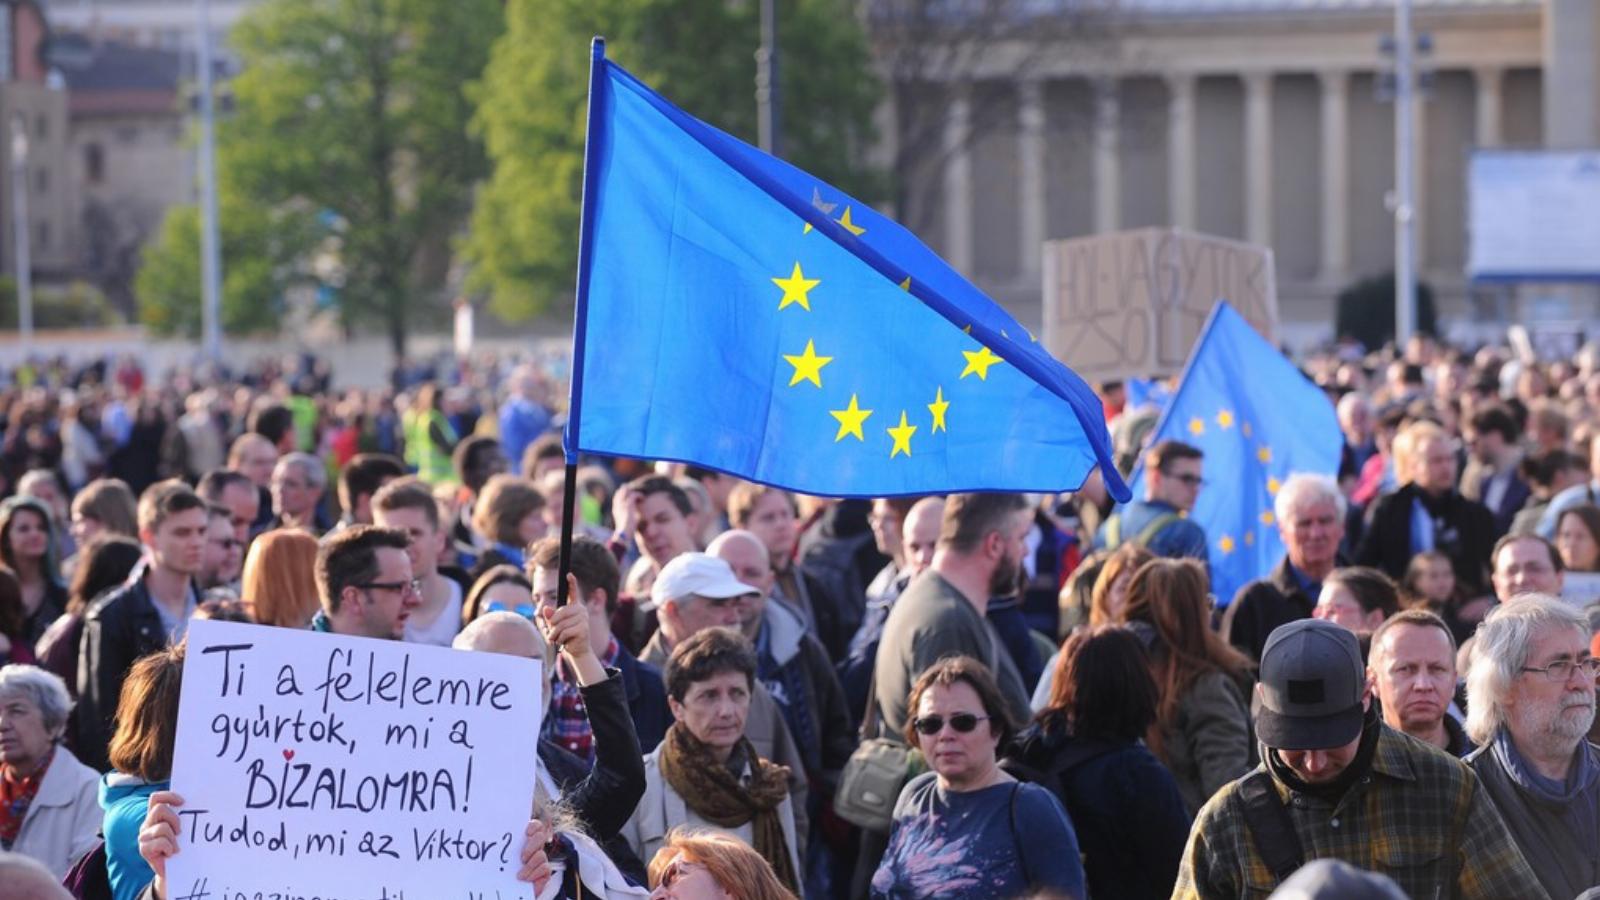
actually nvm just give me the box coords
[0,340,1600,900]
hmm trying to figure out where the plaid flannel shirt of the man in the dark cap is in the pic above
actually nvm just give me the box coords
[1173,725,1565,900]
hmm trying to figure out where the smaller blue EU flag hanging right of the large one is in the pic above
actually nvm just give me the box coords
[1131,303,1342,604]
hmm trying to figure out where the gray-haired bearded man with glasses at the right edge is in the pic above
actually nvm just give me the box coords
[1467,594,1600,900]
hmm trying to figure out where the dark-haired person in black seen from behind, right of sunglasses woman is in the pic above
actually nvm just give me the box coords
[1003,626,1190,900]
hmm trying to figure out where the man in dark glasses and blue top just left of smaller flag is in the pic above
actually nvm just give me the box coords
[1094,440,1206,562]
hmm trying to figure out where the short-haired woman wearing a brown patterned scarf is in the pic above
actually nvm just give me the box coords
[622,628,802,894]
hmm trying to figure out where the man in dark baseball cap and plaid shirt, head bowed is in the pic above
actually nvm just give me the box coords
[1173,620,1542,900]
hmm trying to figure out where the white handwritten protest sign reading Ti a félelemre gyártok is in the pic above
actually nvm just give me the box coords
[168,620,542,900]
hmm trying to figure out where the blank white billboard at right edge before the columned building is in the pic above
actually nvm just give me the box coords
[1467,151,1600,280]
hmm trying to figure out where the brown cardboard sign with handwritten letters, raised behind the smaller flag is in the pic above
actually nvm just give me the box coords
[1045,227,1278,384]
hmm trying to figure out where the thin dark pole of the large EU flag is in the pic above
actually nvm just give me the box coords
[555,35,605,607]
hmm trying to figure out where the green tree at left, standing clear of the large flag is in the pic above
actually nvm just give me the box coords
[139,0,504,354]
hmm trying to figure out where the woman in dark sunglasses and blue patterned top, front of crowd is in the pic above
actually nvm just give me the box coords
[872,657,1085,900]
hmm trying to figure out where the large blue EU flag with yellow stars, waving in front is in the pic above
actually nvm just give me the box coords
[566,45,1126,496]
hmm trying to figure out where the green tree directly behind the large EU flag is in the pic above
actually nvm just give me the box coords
[466,0,882,319]
